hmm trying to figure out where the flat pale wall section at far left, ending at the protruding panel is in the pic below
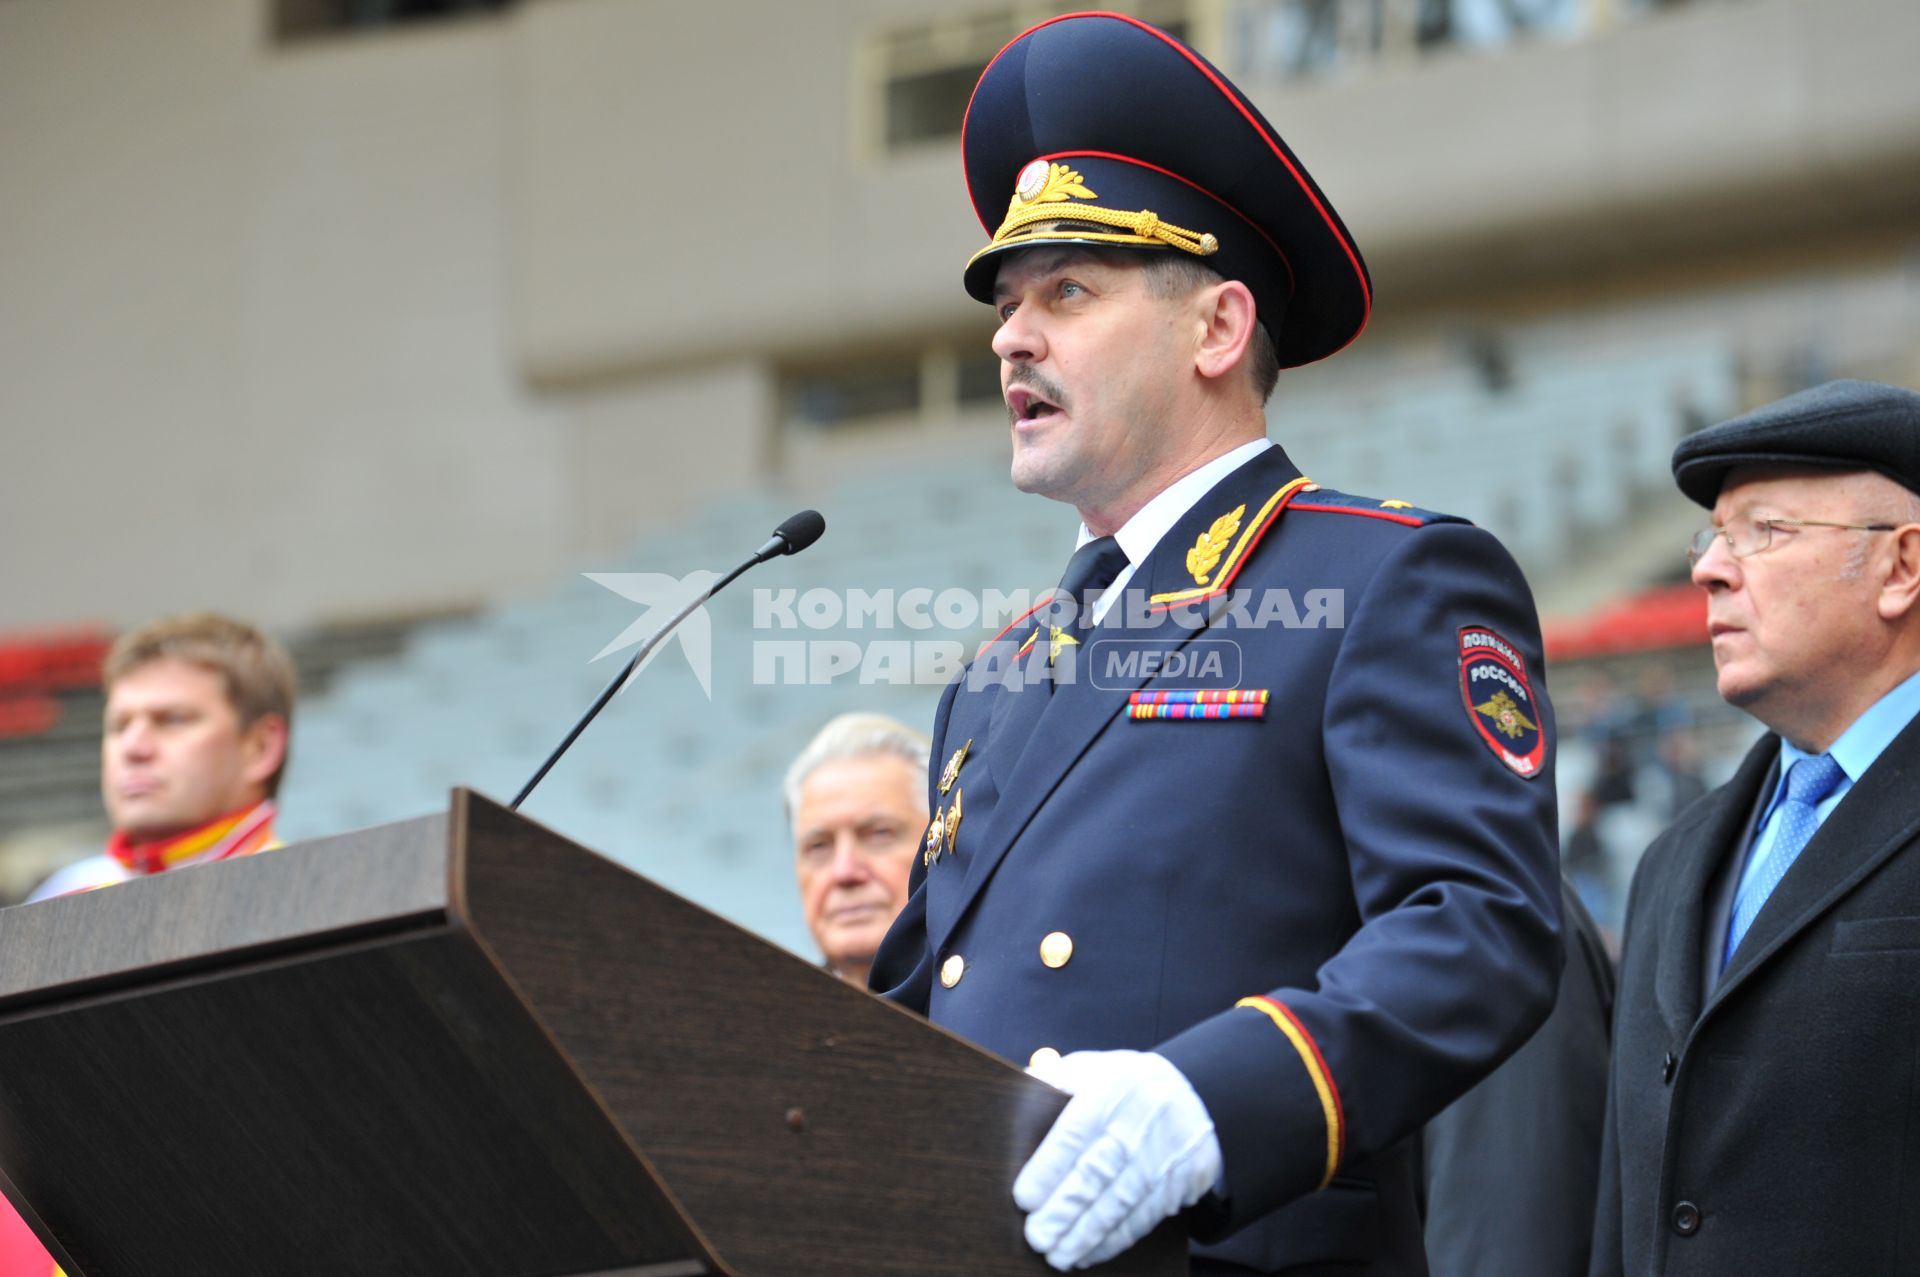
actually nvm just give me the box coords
[0,0,566,624]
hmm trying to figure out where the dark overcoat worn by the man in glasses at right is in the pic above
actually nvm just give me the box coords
[1594,720,1920,1277]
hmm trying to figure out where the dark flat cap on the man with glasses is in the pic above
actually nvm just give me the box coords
[1674,380,1920,509]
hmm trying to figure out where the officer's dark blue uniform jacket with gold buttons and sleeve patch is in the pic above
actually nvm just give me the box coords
[872,447,1561,1273]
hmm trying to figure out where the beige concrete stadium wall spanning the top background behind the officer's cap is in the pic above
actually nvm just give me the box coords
[0,0,1920,628]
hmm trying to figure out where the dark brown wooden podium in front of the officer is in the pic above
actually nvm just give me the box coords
[0,791,1187,1277]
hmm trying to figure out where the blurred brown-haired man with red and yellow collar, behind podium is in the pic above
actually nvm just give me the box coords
[29,613,294,901]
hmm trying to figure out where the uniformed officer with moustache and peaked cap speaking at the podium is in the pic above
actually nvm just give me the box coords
[872,13,1561,1275]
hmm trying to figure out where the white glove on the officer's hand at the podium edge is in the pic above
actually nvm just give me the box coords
[1014,1050,1221,1271]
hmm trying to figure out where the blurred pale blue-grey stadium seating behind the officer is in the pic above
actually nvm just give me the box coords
[282,342,1736,952]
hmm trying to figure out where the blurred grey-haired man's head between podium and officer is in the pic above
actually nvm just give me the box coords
[783,714,927,987]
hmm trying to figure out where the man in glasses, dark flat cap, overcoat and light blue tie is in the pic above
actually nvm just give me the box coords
[1594,382,1920,1277]
